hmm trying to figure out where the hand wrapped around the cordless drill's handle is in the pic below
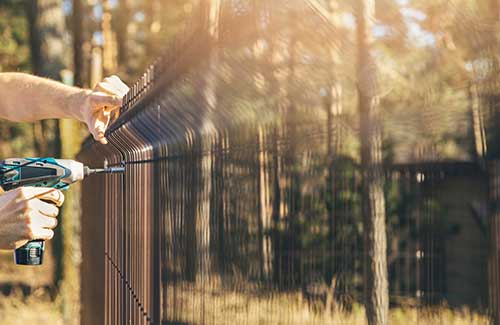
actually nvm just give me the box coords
[0,187,64,249]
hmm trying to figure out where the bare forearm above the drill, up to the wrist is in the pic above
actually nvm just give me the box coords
[0,73,88,122]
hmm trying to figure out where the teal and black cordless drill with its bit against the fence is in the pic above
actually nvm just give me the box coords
[0,158,125,265]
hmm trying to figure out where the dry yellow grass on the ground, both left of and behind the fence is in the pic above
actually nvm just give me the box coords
[0,275,489,325]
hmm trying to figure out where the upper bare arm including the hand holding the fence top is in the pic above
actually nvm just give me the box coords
[0,73,128,143]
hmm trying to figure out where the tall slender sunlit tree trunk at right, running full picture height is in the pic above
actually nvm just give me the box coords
[356,0,389,325]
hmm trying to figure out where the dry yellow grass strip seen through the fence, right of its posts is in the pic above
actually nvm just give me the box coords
[165,285,490,325]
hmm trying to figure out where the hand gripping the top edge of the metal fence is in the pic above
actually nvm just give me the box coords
[79,76,129,144]
